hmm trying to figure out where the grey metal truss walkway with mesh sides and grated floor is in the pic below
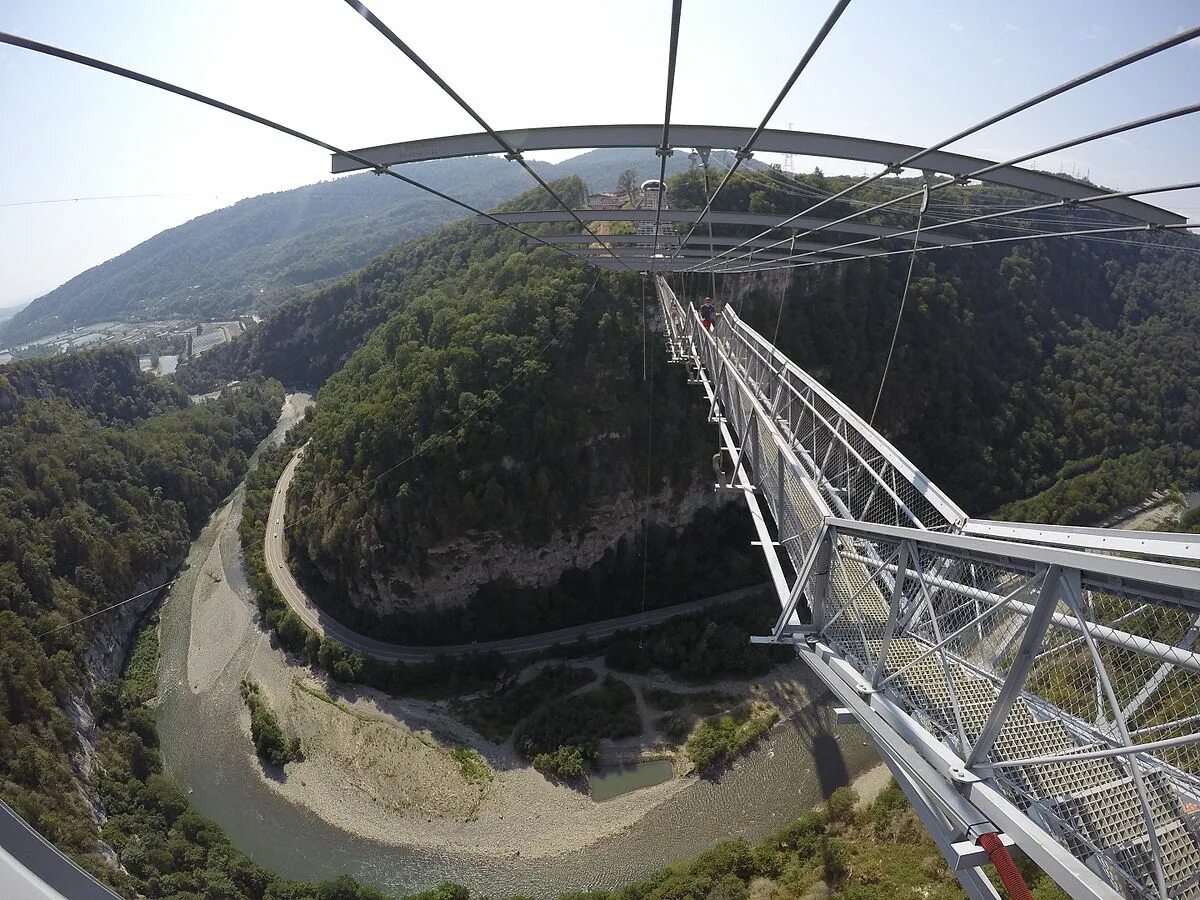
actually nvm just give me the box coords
[655,278,1200,900]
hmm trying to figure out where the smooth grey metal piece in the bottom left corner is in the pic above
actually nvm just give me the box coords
[0,802,120,900]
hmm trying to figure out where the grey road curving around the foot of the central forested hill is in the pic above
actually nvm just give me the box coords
[264,448,768,662]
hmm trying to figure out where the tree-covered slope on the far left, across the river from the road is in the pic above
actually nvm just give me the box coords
[0,350,282,883]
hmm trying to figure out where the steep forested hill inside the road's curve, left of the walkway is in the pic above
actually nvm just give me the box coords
[280,179,762,641]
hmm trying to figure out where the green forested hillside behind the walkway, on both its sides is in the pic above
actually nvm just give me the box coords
[270,173,1200,637]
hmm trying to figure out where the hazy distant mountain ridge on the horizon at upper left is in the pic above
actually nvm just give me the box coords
[0,150,688,346]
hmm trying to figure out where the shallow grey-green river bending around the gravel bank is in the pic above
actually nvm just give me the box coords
[157,395,877,898]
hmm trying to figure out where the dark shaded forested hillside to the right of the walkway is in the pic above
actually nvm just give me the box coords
[691,166,1200,521]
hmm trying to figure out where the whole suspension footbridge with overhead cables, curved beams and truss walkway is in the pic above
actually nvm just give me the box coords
[0,0,1200,900]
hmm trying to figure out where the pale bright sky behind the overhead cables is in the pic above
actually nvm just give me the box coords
[0,0,1200,307]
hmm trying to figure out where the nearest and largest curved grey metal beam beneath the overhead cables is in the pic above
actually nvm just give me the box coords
[331,124,1187,224]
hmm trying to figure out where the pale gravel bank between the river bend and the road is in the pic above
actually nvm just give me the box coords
[166,398,886,858]
